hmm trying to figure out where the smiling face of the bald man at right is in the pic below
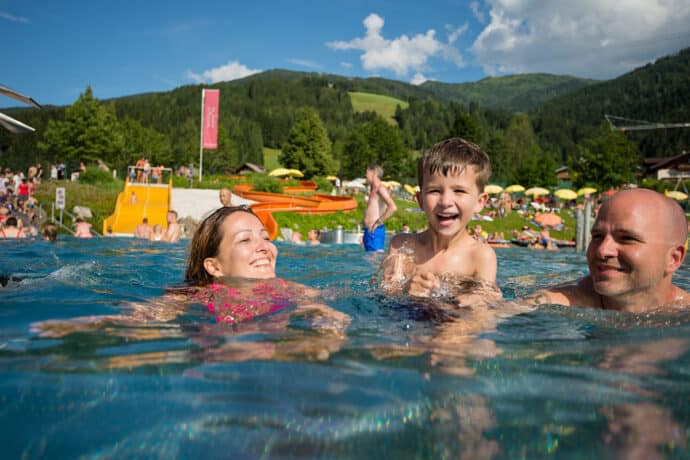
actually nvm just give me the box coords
[587,196,671,302]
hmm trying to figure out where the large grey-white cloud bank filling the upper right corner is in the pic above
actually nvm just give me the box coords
[471,0,690,78]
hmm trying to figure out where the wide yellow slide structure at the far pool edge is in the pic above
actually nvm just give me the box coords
[103,178,172,236]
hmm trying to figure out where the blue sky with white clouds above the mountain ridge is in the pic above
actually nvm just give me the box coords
[0,0,690,107]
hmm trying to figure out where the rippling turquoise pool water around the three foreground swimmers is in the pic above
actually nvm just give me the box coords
[0,238,690,459]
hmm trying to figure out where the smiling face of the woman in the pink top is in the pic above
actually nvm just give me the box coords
[204,211,278,279]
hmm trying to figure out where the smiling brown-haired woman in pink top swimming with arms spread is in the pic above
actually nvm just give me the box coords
[34,206,350,360]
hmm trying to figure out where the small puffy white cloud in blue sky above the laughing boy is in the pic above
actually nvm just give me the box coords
[326,13,465,76]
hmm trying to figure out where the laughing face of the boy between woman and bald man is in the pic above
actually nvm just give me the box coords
[417,166,487,236]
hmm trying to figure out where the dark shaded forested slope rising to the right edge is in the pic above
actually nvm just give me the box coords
[531,48,690,157]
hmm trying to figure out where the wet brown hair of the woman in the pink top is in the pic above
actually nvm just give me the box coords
[184,205,258,286]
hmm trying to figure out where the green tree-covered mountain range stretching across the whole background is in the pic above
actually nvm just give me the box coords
[0,49,690,189]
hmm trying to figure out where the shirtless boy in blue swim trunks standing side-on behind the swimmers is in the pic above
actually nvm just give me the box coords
[362,164,398,252]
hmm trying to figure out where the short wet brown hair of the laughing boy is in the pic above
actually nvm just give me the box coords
[417,137,491,193]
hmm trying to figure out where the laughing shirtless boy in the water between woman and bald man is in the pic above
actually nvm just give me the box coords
[381,138,500,303]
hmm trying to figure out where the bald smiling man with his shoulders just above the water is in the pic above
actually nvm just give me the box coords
[525,189,690,313]
